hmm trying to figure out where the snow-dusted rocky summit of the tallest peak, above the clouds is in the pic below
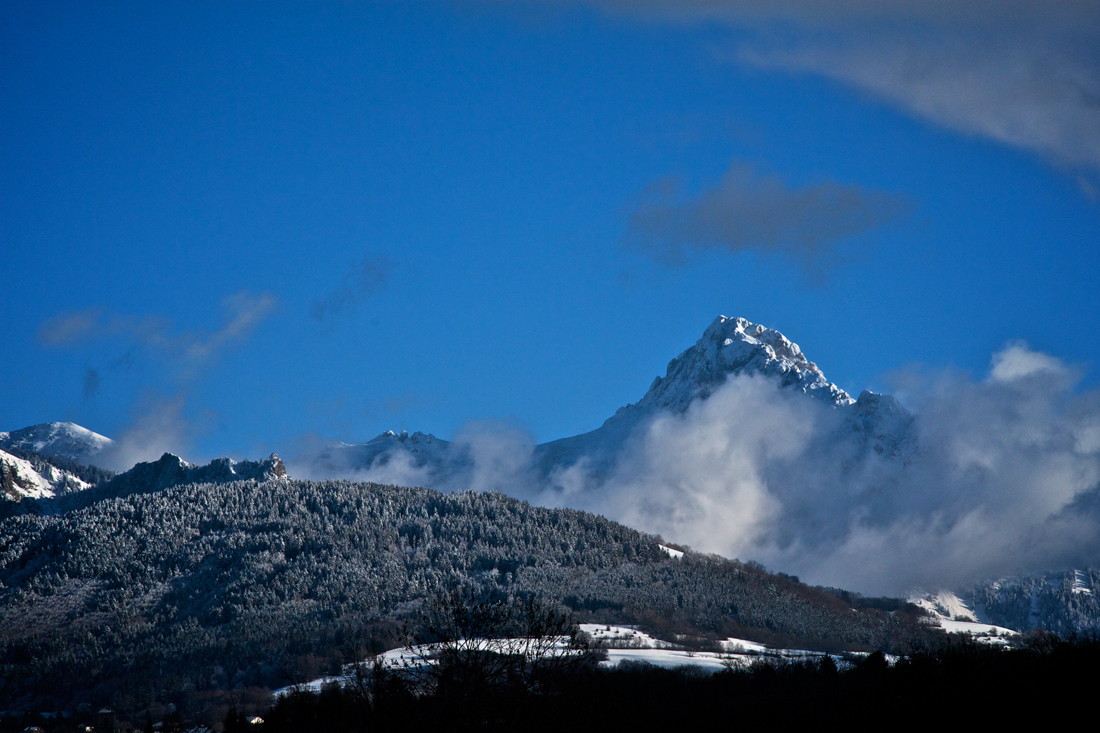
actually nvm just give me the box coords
[638,316,855,412]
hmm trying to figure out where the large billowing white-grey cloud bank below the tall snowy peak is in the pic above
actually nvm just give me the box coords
[576,343,1100,593]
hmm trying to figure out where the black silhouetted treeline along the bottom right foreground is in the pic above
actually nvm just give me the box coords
[261,635,1100,733]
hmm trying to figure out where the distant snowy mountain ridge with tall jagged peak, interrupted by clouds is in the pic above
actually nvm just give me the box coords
[299,316,912,488]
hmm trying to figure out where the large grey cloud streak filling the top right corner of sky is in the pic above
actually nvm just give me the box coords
[593,0,1100,177]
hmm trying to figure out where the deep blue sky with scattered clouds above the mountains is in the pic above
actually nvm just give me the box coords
[0,1,1100,459]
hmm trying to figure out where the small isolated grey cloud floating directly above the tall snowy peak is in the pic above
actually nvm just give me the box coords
[628,163,909,273]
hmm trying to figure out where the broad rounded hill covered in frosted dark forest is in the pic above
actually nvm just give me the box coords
[0,479,915,710]
